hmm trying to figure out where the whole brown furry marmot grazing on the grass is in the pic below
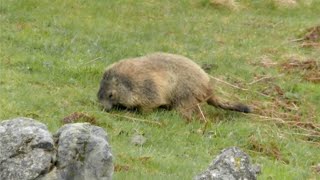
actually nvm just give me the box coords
[97,53,251,120]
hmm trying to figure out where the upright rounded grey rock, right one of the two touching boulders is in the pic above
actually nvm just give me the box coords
[54,123,113,180]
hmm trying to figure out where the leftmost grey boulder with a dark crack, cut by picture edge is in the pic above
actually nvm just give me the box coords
[0,118,55,180]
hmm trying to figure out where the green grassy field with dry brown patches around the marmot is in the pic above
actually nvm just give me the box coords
[0,0,320,179]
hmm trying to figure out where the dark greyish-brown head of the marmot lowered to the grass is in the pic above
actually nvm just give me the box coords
[97,69,133,111]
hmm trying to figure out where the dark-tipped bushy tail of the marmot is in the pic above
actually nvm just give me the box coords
[207,97,251,113]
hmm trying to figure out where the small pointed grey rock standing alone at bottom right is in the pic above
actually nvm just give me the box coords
[194,147,260,180]
